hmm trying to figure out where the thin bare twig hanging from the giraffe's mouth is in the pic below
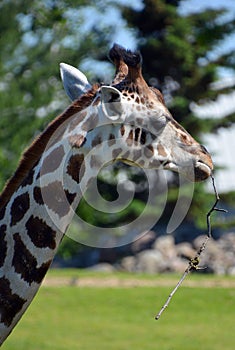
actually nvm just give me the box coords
[155,175,227,320]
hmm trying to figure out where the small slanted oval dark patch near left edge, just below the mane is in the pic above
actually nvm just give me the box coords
[11,192,30,226]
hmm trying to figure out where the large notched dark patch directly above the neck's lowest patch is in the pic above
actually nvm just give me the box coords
[12,232,51,285]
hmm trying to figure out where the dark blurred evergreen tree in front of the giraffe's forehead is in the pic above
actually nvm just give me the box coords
[121,0,235,227]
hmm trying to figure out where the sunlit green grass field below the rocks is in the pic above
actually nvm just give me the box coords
[2,270,235,350]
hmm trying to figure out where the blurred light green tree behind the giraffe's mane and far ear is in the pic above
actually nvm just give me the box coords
[0,0,112,188]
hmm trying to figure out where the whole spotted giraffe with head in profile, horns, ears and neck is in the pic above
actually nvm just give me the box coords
[0,44,213,344]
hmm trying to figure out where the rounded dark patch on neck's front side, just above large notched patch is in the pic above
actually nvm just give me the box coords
[25,216,56,249]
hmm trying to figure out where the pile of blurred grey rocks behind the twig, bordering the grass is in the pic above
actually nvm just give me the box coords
[121,232,235,276]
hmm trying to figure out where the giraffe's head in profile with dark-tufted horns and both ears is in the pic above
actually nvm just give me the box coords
[61,44,213,181]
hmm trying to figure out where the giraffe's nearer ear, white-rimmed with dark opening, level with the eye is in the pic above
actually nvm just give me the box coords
[101,86,123,121]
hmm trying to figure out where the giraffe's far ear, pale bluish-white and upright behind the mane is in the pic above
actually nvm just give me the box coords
[60,63,91,101]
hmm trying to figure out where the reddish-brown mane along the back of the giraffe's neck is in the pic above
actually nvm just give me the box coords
[0,84,99,209]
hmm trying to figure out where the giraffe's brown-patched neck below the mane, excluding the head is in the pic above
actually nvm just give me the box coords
[0,111,149,344]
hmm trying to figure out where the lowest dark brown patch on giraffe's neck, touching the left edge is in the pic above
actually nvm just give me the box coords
[0,277,26,327]
